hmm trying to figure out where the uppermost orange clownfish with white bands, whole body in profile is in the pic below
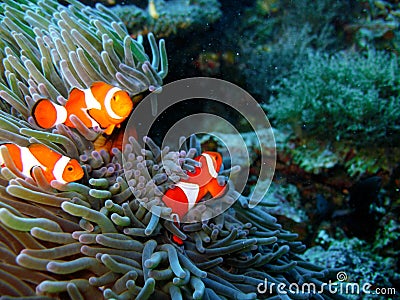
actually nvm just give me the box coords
[32,82,133,135]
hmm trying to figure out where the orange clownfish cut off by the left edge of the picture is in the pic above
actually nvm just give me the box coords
[0,143,84,183]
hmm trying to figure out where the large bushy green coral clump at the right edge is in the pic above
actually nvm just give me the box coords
[266,51,400,175]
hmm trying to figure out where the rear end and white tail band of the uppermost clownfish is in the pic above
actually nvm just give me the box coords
[32,99,68,129]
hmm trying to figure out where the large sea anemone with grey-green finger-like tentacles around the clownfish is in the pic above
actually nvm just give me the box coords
[0,0,344,299]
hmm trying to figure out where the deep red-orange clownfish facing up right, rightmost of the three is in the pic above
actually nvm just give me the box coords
[162,151,225,220]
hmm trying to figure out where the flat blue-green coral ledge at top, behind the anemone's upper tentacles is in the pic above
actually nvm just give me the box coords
[112,0,221,37]
